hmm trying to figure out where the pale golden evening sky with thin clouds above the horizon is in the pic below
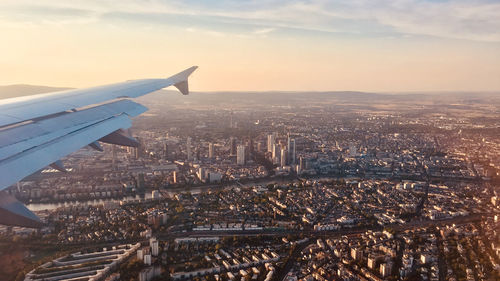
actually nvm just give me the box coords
[0,0,500,92]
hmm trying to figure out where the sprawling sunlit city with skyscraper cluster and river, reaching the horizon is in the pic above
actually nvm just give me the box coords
[0,90,500,281]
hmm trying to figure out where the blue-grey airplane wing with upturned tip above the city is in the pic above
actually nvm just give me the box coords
[0,66,197,226]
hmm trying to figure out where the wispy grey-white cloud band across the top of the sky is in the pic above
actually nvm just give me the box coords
[0,0,500,42]
